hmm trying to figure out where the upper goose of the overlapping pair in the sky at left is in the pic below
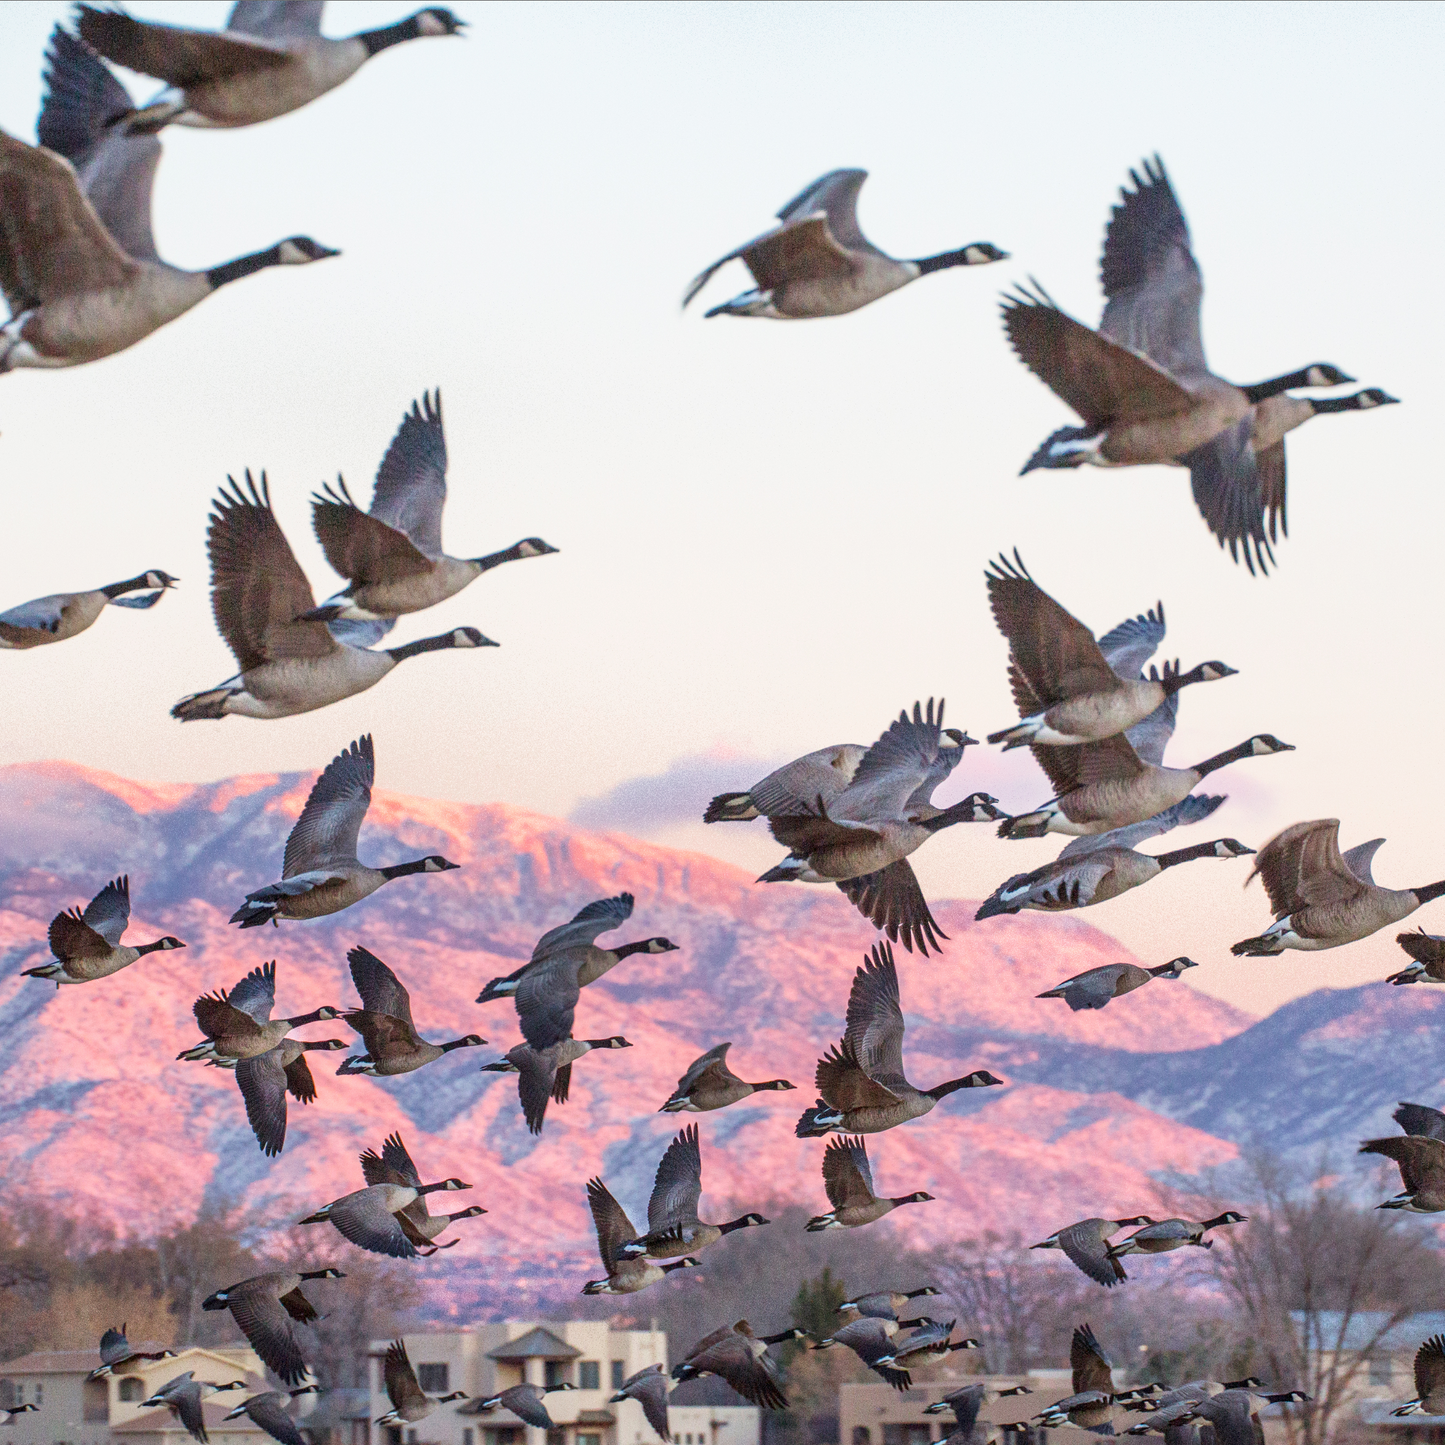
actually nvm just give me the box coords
[297,390,556,646]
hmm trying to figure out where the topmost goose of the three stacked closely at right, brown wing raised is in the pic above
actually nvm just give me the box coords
[984,549,1237,762]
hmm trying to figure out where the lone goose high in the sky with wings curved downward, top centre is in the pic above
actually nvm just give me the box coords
[682,171,1009,319]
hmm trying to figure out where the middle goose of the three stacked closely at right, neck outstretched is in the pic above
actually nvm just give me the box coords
[998,733,1295,838]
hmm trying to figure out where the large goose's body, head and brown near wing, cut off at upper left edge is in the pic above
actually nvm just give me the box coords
[0,130,340,374]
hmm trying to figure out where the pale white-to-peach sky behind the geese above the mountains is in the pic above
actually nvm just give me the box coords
[0,0,1445,1012]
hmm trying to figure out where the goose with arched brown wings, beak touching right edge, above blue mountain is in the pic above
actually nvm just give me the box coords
[1230,818,1445,958]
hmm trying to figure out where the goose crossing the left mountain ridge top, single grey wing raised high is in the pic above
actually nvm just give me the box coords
[231,733,461,928]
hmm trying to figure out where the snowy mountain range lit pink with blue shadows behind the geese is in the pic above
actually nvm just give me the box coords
[0,759,1421,1308]
